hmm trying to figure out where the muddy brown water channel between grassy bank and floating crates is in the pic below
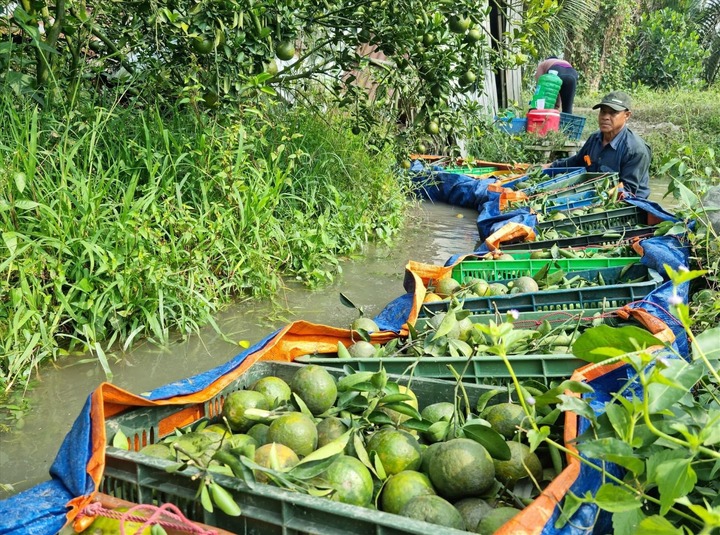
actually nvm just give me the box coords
[0,203,478,499]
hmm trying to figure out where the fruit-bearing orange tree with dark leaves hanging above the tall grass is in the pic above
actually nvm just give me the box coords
[0,0,557,149]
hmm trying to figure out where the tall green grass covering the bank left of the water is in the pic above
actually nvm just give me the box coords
[0,98,407,398]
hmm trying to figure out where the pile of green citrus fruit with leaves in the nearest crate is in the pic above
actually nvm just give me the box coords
[141,365,561,533]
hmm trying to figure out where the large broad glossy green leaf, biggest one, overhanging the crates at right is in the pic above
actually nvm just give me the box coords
[572,325,664,362]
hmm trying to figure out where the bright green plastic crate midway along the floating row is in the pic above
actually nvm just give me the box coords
[452,256,639,284]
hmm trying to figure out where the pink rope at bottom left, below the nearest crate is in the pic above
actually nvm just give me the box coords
[78,502,218,535]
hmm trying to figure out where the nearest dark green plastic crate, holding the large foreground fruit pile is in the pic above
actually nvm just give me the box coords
[98,361,501,535]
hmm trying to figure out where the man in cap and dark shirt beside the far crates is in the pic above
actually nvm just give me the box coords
[543,91,652,199]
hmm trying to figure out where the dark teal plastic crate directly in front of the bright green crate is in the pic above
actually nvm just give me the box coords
[420,264,663,316]
